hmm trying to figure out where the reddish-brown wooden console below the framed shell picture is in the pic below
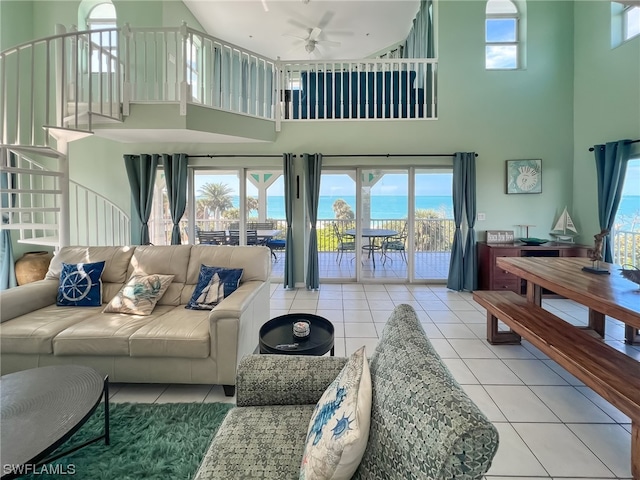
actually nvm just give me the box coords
[478,242,591,294]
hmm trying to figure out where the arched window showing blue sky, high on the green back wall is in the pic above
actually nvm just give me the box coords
[485,0,520,70]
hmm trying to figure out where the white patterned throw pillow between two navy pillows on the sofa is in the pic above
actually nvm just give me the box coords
[104,273,173,315]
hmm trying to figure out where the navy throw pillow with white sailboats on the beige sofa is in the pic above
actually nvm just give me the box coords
[185,265,243,310]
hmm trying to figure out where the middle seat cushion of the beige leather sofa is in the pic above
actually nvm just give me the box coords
[53,305,172,356]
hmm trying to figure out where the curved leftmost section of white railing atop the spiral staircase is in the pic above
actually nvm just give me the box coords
[0,24,122,148]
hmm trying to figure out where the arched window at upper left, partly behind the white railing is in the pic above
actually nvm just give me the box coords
[86,2,118,73]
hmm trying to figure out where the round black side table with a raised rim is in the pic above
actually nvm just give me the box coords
[259,313,335,356]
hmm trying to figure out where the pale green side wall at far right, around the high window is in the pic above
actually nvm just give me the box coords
[572,1,640,244]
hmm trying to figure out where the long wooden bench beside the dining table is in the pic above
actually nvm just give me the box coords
[473,290,640,480]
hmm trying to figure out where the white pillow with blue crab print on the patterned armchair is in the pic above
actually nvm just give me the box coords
[300,347,371,480]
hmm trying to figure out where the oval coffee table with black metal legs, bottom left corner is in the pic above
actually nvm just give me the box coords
[0,365,109,480]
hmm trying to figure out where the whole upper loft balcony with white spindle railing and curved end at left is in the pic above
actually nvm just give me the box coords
[0,25,437,148]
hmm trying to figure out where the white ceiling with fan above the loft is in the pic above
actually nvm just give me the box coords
[183,0,420,60]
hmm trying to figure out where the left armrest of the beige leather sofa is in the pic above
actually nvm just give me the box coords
[0,279,58,323]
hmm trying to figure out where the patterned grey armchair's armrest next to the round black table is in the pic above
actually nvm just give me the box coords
[236,355,347,407]
